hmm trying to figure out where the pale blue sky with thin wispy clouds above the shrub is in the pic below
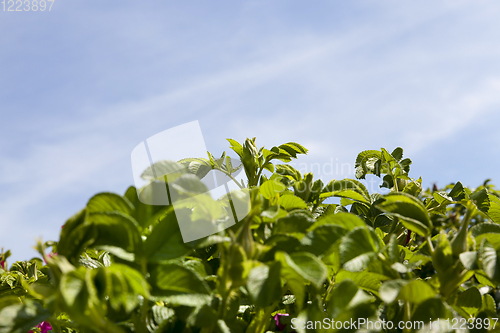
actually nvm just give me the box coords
[0,0,500,261]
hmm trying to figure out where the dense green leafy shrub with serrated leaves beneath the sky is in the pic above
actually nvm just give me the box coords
[0,138,500,333]
